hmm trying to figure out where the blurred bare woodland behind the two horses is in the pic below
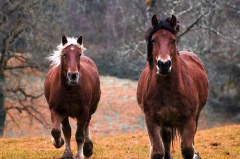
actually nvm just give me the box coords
[0,0,240,136]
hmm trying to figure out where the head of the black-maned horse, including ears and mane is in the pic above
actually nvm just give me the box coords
[146,15,179,76]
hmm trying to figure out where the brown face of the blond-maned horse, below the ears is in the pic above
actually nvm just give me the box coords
[62,45,82,85]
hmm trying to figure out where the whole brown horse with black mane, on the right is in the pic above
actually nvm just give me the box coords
[137,15,208,159]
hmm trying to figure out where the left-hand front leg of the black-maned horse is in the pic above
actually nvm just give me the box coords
[145,116,165,159]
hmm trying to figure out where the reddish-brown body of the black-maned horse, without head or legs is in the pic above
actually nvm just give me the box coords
[137,52,208,128]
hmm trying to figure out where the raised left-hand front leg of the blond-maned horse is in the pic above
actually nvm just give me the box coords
[51,109,64,148]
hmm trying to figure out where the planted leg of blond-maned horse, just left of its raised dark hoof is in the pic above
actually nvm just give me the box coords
[75,108,89,159]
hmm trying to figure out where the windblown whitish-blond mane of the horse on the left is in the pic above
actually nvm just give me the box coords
[47,37,86,66]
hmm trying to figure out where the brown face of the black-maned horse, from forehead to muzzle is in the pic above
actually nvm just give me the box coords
[152,29,176,75]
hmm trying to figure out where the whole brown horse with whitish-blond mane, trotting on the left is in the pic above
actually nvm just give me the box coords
[44,36,101,159]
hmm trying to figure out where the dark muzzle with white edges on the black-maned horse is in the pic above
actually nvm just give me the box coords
[157,60,172,76]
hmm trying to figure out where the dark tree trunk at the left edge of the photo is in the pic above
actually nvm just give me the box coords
[0,69,6,137]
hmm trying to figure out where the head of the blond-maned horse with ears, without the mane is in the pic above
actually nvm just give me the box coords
[61,36,82,85]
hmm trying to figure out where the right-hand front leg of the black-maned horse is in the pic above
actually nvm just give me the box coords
[181,119,196,159]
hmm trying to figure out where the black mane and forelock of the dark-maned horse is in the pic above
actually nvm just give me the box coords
[145,17,180,66]
